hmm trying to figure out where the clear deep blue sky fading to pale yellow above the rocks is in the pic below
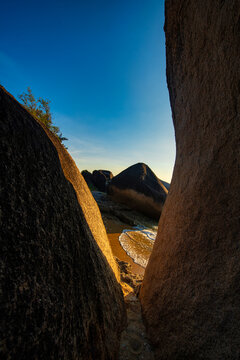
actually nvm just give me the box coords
[0,0,175,181]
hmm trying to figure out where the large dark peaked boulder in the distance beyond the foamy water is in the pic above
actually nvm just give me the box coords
[108,163,167,218]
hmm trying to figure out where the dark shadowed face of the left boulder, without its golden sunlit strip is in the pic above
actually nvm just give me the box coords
[0,88,125,360]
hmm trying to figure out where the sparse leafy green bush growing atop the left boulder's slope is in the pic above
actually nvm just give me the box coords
[18,87,68,143]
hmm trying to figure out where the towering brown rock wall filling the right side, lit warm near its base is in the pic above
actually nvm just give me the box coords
[140,0,240,360]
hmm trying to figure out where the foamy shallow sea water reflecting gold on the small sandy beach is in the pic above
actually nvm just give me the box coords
[119,226,157,268]
